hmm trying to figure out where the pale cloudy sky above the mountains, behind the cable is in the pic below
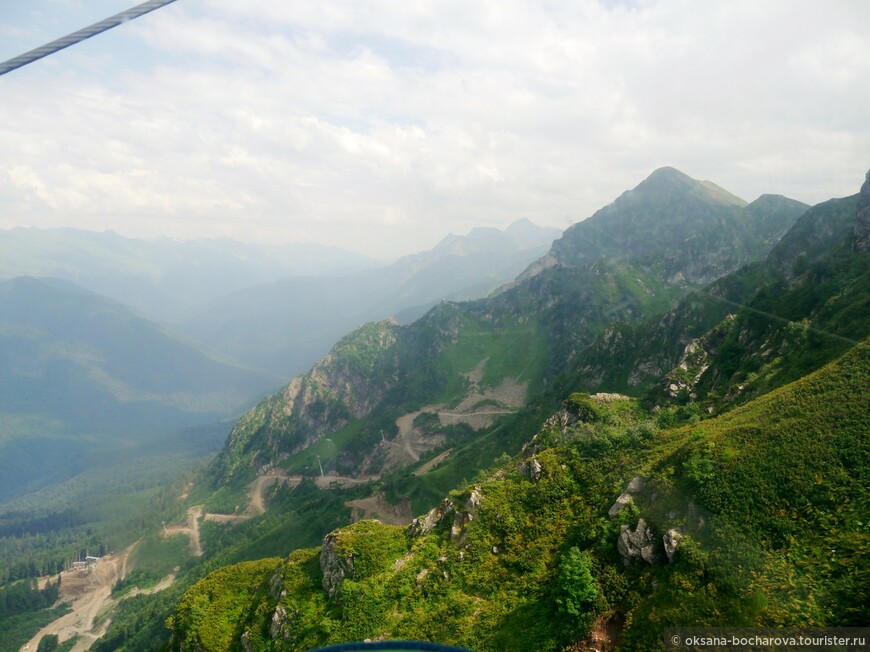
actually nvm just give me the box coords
[0,0,870,258]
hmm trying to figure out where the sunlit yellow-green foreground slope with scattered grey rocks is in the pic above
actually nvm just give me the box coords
[171,341,870,651]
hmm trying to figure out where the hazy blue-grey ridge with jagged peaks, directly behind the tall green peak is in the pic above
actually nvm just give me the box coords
[181,220,560,377]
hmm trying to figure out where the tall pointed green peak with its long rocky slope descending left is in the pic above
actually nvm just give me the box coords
[216,168,805,493]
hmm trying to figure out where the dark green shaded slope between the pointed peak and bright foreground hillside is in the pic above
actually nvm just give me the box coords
[573,187,870,409]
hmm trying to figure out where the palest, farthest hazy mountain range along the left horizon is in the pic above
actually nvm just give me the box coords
[0,228,377,322]
